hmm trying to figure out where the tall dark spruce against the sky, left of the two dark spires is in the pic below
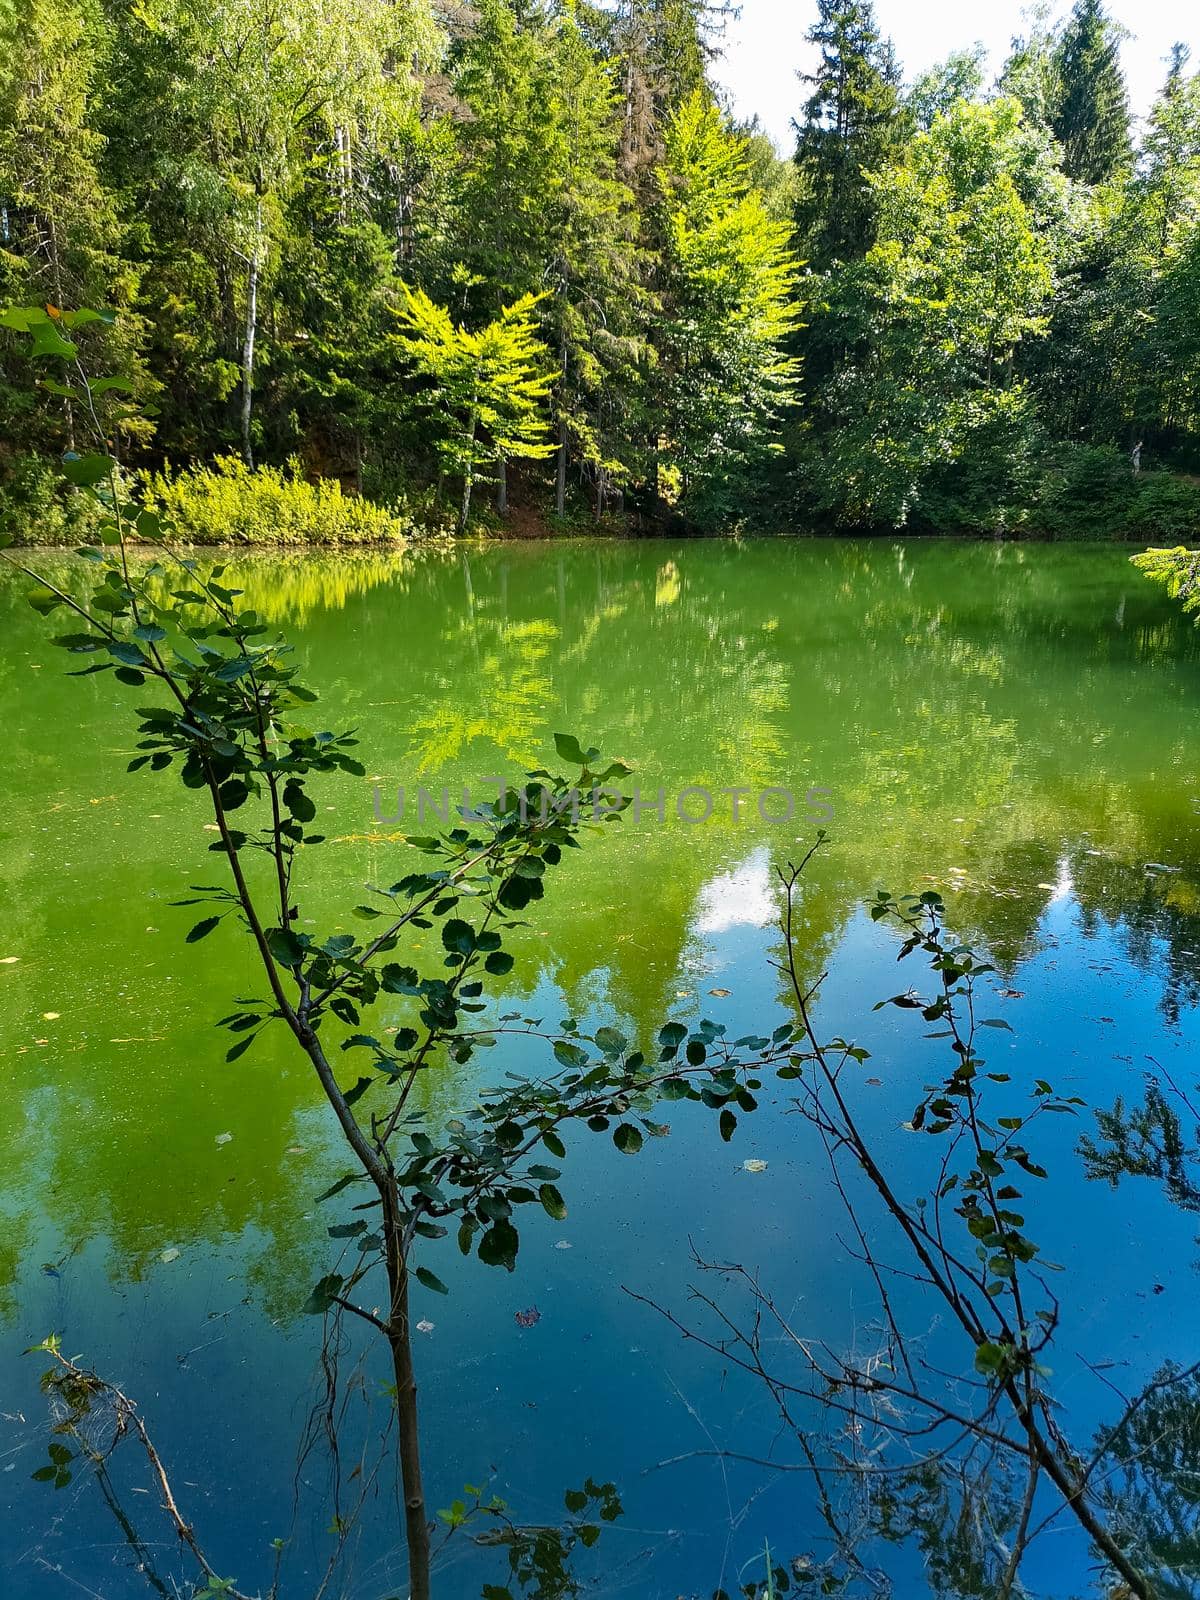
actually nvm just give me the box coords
[795,0,901,269]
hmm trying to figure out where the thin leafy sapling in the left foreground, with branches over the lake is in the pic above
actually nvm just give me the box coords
[0,307,786,1600]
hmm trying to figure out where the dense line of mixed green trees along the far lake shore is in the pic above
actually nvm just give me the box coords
[0,0,1200,536]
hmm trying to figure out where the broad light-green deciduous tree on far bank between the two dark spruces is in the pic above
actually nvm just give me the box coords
[813,99,1053,526]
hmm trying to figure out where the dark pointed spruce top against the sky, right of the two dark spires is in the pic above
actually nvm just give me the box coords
[1050,0,1131,184]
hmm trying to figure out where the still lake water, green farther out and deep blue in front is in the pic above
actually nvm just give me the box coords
[0,541,1200,1600]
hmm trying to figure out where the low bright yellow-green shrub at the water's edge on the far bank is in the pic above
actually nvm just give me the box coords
[144,456,413,546]
